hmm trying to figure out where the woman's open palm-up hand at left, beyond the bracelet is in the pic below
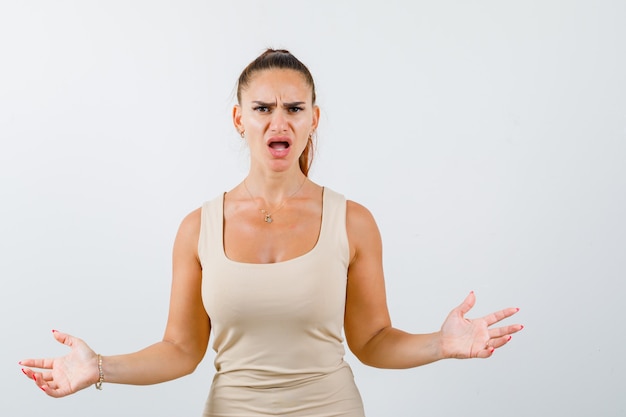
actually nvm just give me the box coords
[19,330,99,397]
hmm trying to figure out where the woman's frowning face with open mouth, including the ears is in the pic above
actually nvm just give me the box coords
[233,69,319,172]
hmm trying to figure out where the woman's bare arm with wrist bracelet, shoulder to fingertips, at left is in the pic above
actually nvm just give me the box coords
[20,210,211,397]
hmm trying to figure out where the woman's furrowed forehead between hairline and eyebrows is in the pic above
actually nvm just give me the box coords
[241,68,313,101]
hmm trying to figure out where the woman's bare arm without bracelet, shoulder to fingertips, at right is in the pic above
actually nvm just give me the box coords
[344,202,522,368]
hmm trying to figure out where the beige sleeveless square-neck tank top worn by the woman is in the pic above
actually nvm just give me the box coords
[198,188,349,388]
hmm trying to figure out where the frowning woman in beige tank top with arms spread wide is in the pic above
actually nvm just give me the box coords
[21,50,522,417]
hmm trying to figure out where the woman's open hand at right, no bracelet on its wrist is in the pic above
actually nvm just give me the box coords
[440,291,524,359]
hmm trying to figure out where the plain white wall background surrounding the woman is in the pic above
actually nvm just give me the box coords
[0,0,626,417]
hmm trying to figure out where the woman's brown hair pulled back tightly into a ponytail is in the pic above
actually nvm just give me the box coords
[237,49,315,176]
